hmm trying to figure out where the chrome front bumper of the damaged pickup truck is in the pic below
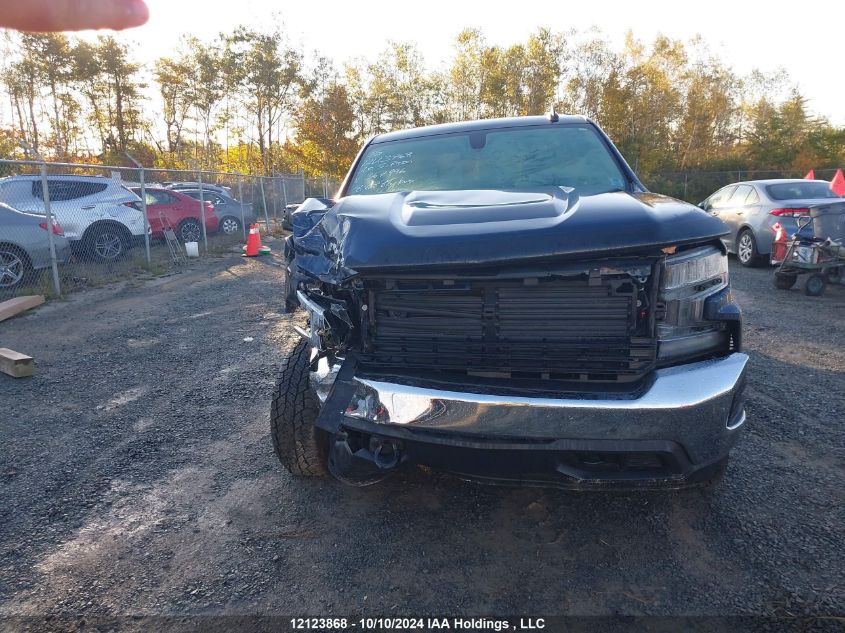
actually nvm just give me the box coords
[315,353,748,464]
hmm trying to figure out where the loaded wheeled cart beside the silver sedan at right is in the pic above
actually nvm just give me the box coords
[772,202,845,297]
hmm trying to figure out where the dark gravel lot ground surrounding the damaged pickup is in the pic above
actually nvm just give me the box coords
[0,246,845,628]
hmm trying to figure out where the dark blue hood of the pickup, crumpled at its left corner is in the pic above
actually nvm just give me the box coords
[294,187,728,282]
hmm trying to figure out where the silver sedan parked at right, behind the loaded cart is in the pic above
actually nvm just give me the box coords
[699,179,838,266]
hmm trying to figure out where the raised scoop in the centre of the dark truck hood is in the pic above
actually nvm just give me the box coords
[402,187,572,226]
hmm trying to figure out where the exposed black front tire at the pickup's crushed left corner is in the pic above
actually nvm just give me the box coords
[270,340,329,477]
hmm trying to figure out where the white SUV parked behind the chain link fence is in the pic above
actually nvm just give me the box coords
[0,176,144,261]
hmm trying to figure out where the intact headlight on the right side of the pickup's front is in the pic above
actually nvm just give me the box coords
[657,246,730,361]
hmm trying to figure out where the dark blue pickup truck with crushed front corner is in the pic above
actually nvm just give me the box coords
[271,113,748,489]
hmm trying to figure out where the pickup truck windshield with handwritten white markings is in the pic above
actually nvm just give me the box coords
[347,125,628,195]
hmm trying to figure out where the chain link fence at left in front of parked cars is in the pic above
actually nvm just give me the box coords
[0,156,333,301]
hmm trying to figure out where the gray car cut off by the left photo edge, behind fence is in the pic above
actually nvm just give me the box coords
[0,203,70,290]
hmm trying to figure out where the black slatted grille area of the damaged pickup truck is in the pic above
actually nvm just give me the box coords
[361,278,655,382]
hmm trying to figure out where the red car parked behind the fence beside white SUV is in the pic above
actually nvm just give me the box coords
[132,187,217,242]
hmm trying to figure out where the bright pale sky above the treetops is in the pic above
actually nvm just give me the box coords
[112,0,845,125]
